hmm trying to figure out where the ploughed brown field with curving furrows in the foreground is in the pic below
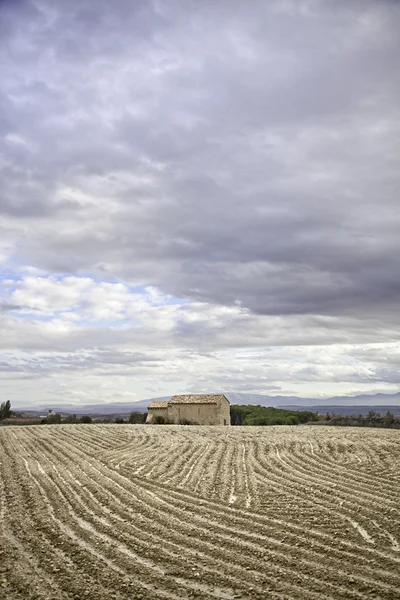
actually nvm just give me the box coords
[0,425,400,600]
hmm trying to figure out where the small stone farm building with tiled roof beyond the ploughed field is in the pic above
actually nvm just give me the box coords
[146,394,231,425]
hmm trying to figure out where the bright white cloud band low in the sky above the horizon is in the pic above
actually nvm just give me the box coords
[0,269,400,405]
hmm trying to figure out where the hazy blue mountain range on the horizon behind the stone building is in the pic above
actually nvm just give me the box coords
[13,392,400,415]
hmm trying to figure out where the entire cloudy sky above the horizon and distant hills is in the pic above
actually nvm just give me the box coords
[0,0,400,406]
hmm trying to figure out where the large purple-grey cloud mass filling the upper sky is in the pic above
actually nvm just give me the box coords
[2,2,400,314]
